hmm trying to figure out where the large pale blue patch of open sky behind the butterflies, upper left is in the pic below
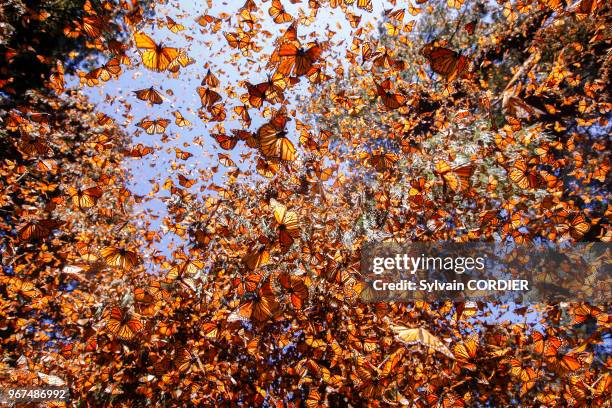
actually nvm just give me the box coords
[69,1,402,260]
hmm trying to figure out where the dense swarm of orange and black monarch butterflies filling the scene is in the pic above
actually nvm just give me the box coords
[0,0,612,408]
